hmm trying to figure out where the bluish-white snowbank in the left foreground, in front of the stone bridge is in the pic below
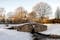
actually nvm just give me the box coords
[0,29,32,40]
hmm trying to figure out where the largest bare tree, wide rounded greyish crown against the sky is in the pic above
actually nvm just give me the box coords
[33,2,52,19]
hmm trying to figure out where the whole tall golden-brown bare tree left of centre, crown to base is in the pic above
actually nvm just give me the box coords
[15,7,27,23]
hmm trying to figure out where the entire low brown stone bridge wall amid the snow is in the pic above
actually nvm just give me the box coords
[7,24,47,32]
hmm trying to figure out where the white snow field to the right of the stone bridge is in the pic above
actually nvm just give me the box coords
[40,24,60,35]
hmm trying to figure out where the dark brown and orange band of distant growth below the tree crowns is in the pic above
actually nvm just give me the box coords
[0,19,60,24]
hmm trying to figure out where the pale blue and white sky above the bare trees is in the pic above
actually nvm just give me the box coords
[0,0,60,17]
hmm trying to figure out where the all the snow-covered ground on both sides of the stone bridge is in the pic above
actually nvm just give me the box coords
[0,24,60,40]
